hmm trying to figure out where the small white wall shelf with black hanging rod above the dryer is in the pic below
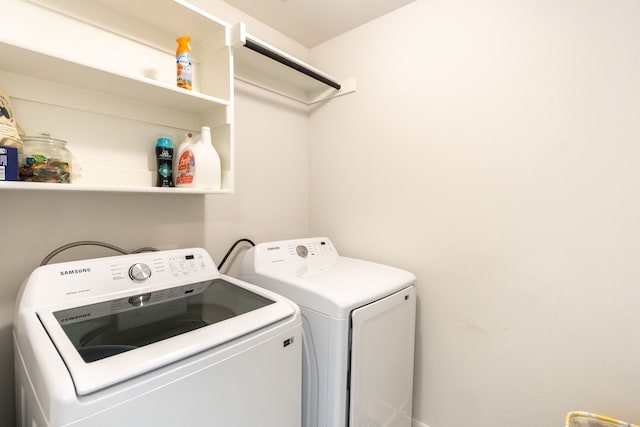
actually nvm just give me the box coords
[230,22,355,105]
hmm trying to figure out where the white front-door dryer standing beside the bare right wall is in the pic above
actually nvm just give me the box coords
[239,238,416,427]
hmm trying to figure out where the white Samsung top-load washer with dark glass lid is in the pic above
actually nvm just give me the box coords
[14,248,302,427]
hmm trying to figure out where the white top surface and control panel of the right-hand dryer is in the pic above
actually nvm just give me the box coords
[240,237,415,318]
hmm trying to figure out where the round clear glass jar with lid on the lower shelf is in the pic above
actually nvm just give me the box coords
[20,134,72,184]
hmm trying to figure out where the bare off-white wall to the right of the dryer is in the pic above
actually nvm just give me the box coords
[309,0,640,427]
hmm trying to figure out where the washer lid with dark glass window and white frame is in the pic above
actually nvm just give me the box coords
[37,277,296,395]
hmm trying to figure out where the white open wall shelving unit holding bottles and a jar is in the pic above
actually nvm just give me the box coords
[0,0,234,194]
